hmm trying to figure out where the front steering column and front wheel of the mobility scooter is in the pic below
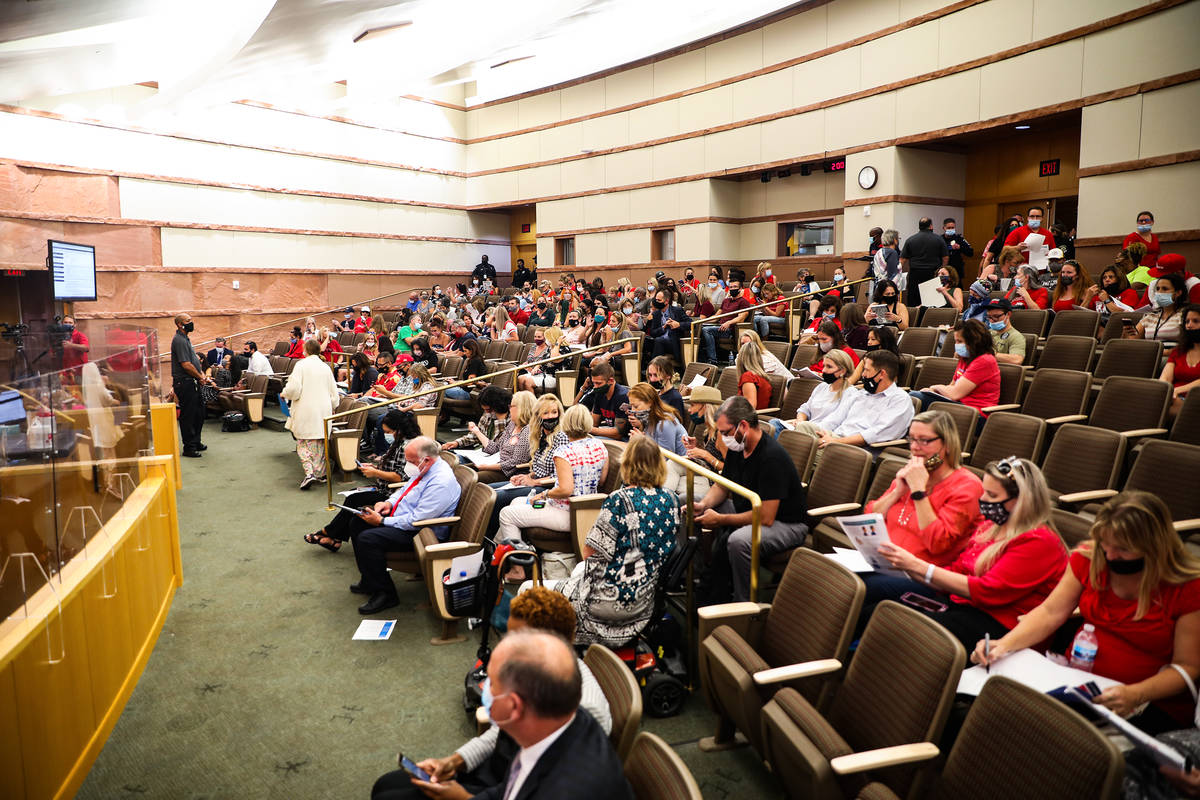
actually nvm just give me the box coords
[462,540,540,715]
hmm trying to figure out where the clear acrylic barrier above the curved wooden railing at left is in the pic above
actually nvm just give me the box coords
[0,321,160,620]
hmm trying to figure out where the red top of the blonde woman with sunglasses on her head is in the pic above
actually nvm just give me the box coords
[946,519,1067,630]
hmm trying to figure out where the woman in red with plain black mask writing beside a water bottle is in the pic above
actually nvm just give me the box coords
[971,492,1200,734]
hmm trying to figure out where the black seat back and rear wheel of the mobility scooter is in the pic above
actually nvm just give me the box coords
[604,539,696,717]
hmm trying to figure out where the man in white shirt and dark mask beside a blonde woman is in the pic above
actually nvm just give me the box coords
[817,350,913,447]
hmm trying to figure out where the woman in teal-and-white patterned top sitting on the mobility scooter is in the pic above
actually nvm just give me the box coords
[559,434,679,648]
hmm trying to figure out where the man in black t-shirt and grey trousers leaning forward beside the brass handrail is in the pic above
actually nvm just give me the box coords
[694,396,809,606]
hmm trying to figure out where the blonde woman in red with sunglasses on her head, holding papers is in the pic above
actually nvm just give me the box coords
[859,457,1067,650]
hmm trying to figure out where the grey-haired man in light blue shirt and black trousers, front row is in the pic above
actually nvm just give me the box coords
[350,437,462,614]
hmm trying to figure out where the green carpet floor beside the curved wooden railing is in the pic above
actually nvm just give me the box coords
[78,422,780,800]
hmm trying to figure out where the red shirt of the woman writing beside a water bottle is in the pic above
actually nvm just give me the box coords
[1070,551,1200,722]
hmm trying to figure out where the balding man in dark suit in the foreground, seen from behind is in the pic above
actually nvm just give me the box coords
[413,630,634,800]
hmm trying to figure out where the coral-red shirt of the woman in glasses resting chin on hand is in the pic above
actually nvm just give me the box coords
[865,468,983,566]
